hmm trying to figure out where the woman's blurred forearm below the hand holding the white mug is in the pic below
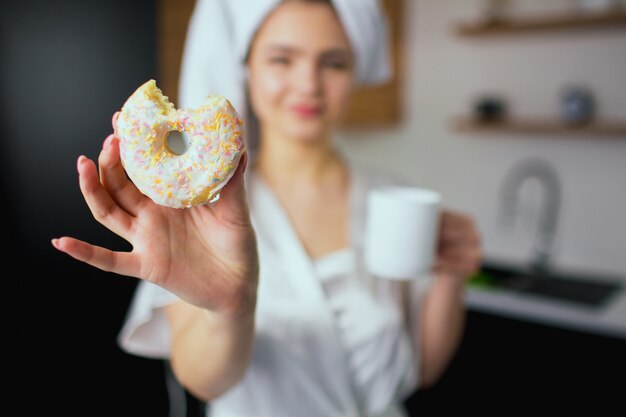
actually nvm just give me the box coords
[420,273,466,387]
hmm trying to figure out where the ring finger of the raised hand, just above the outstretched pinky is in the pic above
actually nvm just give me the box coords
[77,155,132,240]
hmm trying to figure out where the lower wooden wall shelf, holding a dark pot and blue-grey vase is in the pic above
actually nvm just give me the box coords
[453,118,626,139]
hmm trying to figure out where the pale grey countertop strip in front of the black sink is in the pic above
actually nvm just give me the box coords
[465,283,626,340]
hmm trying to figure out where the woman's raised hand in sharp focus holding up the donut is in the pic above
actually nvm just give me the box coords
[52,113,258,315]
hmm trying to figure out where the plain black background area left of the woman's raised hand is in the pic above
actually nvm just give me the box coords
[0,0,167,416]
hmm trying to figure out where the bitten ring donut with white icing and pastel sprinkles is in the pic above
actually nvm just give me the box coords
[117,80,244,208]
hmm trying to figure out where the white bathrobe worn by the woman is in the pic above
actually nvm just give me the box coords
[119,161,429,417]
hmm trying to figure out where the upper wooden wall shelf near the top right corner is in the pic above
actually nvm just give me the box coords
[456,10,626,37]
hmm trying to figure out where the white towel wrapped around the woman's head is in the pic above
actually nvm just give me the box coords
[179,0,392,117]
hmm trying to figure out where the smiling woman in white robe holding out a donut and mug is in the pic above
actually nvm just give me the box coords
[53,0,480,416]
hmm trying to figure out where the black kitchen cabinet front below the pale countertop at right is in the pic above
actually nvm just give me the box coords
[406,309,626,416]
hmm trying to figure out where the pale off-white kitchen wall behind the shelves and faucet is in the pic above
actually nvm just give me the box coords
[338,0,626,276]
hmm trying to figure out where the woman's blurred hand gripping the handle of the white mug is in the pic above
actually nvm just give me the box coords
[434,210,482,279]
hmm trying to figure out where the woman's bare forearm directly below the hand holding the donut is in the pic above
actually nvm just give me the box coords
[168,296,255,401]
